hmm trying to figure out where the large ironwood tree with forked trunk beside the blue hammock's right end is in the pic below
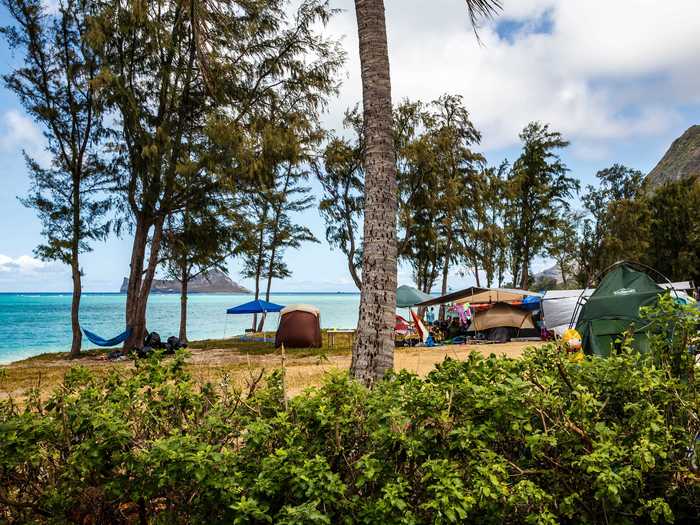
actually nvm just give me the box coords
[91,0,343,348]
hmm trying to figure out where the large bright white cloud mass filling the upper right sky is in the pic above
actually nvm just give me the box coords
[326,0,700,158]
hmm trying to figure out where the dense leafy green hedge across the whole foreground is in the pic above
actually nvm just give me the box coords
[0,338,700,524]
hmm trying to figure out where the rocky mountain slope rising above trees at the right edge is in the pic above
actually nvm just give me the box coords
[646,125,700,188]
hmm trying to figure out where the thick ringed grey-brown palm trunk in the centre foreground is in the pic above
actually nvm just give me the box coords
[351,0,397,387]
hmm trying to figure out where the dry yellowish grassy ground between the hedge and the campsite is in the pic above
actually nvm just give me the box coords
[0,333,537,401]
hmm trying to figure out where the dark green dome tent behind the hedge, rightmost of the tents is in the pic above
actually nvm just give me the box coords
[576,263,664,357]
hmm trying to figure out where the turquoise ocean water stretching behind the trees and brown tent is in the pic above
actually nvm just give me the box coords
[0,293,360,363]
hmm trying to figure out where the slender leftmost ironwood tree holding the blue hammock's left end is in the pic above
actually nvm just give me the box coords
[0,0,114,356]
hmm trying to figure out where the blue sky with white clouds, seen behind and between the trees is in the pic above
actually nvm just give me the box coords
[0,0,700,292]
